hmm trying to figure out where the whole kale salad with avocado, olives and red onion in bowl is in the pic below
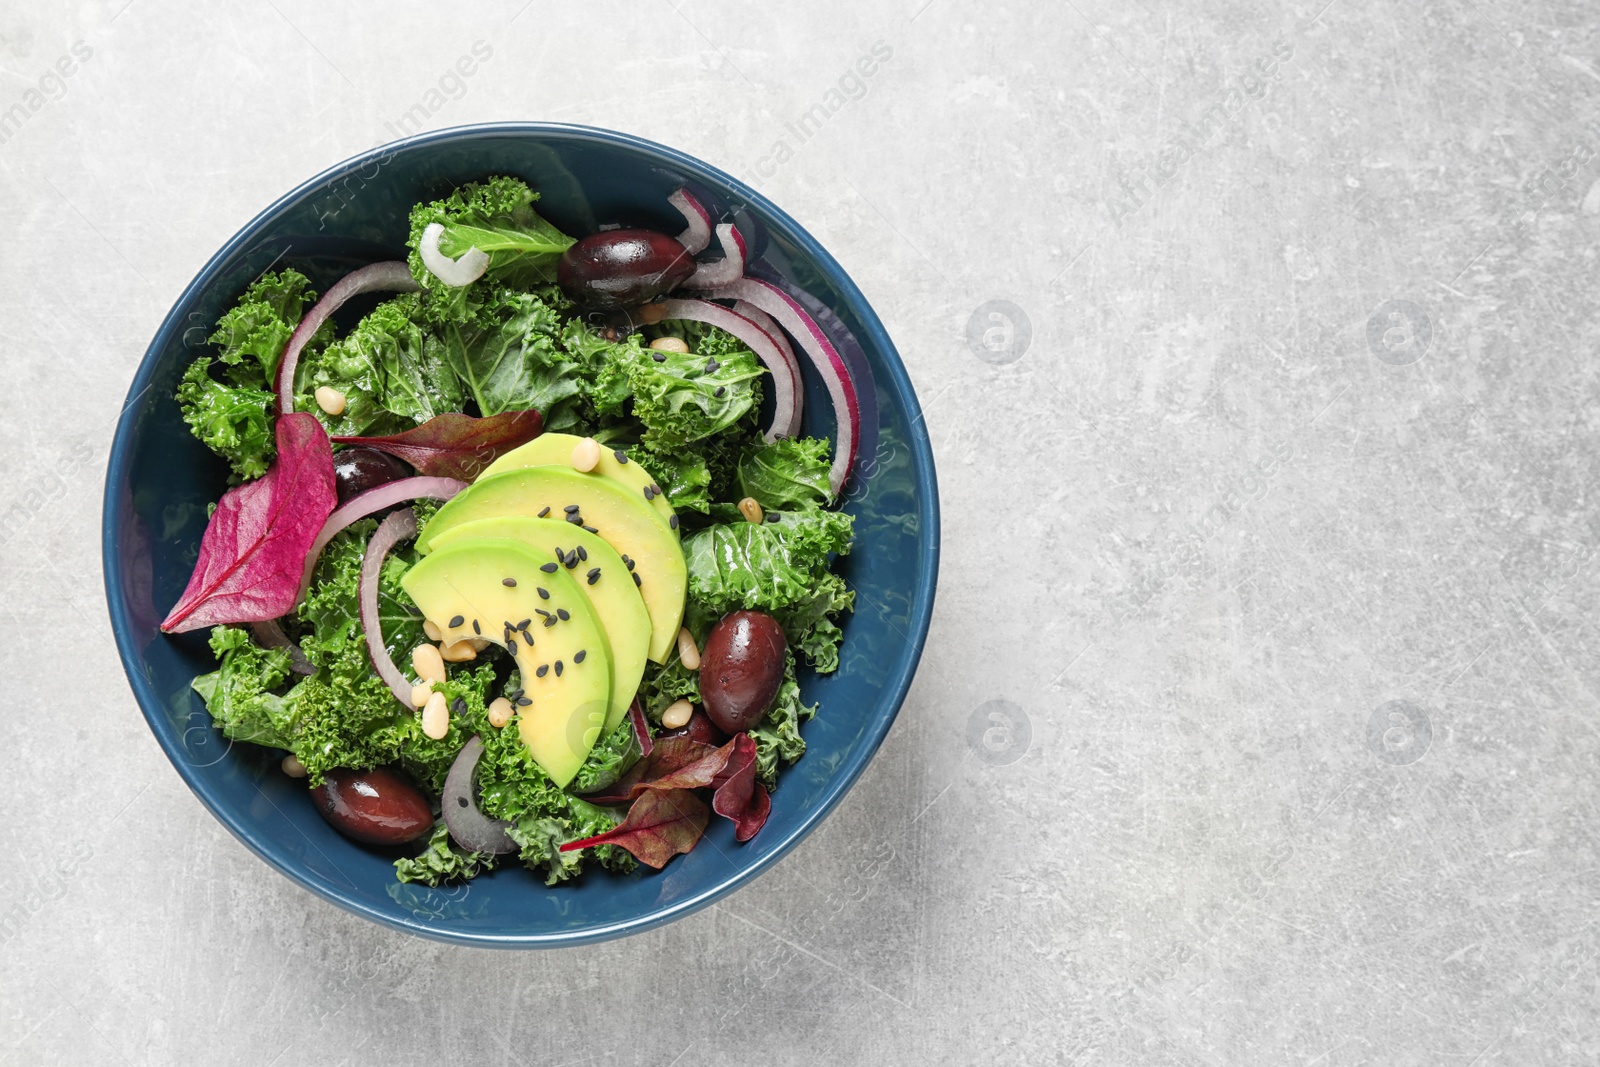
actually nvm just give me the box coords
[162,178,859,885]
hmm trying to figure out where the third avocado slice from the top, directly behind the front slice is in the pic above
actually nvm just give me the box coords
[434,515,650,733]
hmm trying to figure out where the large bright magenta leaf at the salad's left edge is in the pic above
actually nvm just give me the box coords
[162,411,338,633]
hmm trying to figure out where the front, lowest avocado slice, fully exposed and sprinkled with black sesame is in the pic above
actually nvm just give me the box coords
[400,537,611,789]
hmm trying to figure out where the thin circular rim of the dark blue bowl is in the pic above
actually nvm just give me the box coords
[101,122,939,949]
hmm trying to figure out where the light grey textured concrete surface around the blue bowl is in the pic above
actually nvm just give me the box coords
[0,0,1600,1067]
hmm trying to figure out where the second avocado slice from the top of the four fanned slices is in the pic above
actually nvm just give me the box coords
[416,467,688,664]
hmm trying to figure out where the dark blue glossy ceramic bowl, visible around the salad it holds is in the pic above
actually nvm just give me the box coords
[104,123,939,947]
